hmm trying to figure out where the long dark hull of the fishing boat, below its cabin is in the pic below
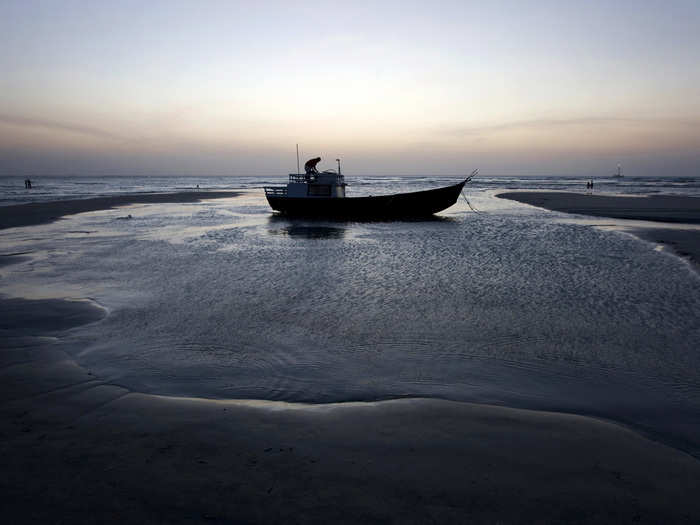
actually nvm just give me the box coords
[267,181,466,218]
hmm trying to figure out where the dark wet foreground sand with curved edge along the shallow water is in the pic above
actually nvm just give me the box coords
[0,299,700,524]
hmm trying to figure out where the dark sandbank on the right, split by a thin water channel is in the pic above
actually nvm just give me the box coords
[496,191,700,265]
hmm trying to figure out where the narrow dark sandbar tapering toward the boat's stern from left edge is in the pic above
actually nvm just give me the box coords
[0,190,240,230]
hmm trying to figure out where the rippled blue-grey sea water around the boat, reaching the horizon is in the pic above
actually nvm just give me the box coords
[0,176,700,456]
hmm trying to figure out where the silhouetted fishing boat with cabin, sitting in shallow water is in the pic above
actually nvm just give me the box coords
[264,159,477,219]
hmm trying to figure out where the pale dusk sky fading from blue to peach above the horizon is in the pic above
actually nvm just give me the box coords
[0,0,700,176]
